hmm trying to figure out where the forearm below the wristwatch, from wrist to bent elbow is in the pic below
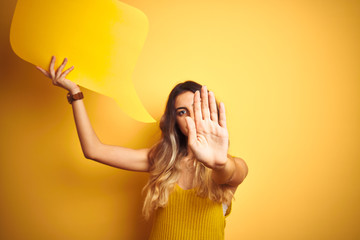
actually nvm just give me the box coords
[71,88,101,158]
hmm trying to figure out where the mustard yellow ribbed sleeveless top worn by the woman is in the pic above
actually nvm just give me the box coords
[149,185,231,240]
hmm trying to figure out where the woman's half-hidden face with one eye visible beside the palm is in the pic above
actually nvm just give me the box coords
[175,91,194,136]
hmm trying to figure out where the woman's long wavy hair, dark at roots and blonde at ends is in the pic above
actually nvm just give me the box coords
[142,81,233,219]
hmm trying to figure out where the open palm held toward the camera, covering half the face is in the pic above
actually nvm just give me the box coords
[186,86,229,169]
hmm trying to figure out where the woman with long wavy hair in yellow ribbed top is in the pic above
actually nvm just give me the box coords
[37,56,248,239]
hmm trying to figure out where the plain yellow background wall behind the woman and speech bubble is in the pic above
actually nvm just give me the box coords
[0,0,360,240]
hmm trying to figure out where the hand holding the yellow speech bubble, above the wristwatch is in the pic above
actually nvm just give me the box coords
[36,56,79,93]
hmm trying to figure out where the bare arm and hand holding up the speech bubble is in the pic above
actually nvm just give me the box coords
[36,56,149,172]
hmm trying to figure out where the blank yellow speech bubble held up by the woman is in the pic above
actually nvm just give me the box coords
[10,0,155,122]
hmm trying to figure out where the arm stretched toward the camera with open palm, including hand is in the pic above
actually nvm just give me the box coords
[186,86,248,188]
